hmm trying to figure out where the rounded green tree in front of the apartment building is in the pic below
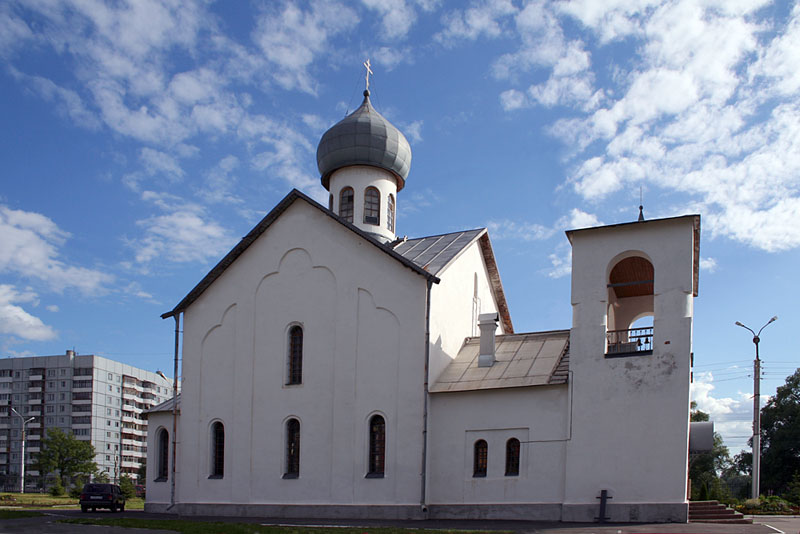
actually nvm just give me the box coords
[37,428,97,492]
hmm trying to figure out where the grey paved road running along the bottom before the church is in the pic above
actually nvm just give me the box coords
[0,510,800,534]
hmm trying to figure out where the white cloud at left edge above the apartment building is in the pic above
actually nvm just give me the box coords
[0,206,113,294]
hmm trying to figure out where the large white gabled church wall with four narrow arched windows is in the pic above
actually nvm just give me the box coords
[178,200,426,504]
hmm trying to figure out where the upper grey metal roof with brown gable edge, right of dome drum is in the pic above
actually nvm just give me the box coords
[394,228,514,334]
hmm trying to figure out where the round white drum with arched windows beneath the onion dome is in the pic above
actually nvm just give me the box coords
[329,165,397,241]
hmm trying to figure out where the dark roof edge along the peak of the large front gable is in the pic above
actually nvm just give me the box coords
[161,189,439,319]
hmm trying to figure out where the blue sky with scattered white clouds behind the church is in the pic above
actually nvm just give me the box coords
[0,0,800,452]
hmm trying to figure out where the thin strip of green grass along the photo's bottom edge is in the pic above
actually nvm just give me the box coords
[60,518,488,534]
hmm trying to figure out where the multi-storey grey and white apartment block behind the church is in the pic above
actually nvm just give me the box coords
[0,350,172,490]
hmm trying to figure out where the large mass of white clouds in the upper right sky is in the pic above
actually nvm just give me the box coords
[493,0,800,253]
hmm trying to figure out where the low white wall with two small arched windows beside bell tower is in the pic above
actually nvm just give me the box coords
[428,385,570,504]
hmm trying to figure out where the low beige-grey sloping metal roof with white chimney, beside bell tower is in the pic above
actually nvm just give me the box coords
[429,330,569,393]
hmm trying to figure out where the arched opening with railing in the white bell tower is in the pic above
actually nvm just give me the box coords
[606,253,655,356]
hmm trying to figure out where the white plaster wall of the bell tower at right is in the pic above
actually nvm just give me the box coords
[565,218,694,520]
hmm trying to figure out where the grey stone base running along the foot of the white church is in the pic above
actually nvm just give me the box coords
[144,503,689,523]
